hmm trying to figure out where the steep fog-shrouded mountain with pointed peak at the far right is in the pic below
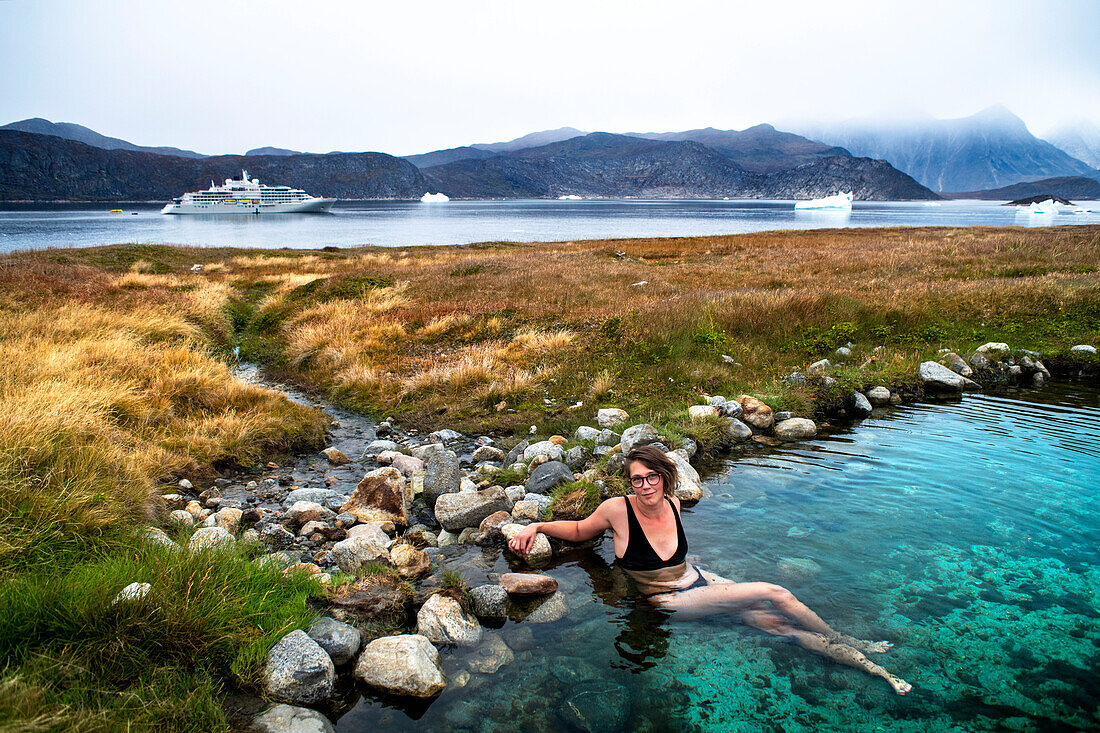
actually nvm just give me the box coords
[791,105,1100,192]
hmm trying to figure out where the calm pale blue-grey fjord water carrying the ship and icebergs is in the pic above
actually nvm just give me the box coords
[0,199,1100,252]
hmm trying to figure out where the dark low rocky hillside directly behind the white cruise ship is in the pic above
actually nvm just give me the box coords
[0,130,428,200]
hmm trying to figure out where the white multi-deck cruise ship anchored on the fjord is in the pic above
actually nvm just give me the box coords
[161,171,337,214]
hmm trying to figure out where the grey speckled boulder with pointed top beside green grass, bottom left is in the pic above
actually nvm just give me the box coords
[264,628,336,705]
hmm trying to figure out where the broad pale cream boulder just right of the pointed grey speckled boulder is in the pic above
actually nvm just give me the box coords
[354,634,447,698]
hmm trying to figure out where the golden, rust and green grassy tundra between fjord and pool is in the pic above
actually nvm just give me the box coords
[0,227,1100,731]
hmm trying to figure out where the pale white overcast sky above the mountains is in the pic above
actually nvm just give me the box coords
[0,0,1100,154]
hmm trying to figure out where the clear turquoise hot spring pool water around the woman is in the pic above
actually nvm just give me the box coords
[338,384,1100,732]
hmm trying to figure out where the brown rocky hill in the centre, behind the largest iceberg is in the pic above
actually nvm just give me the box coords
[425,132,937,199]
